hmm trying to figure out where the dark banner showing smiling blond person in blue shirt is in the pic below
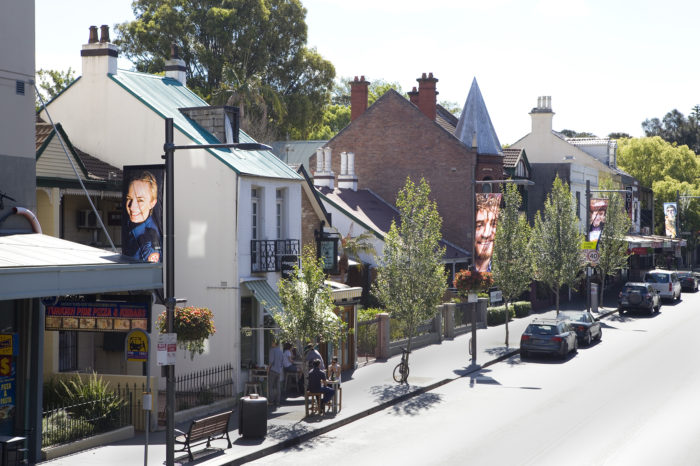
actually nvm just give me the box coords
[122,165,165,262]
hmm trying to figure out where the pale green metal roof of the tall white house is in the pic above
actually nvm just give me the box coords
[109,70,301,180]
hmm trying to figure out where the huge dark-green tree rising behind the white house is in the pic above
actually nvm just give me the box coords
[115,0,335,137]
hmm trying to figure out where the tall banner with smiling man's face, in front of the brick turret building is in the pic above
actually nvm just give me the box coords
[474,193,502,272]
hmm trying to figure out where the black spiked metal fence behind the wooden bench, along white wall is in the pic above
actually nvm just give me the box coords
[175,363,233,411]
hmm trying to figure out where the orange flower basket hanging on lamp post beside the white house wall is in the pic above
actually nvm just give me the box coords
[156,306,216,359]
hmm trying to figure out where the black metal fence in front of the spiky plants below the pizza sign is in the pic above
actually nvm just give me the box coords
[41,393,132,447]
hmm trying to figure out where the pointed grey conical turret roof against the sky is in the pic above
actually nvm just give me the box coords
[455,78,503,155]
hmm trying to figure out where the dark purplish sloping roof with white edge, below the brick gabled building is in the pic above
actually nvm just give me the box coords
[317,187,470,259]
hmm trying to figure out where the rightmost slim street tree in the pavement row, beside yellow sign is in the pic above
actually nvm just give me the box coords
[597,178,632,306]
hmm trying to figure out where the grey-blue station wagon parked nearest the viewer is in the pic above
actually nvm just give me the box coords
[520,319,578,359]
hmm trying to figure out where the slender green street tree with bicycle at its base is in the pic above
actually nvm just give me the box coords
[373,177,447,358]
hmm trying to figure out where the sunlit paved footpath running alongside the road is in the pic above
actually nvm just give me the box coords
[40,290,617,466]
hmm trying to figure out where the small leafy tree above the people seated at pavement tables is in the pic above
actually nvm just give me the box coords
[275,245,346,386]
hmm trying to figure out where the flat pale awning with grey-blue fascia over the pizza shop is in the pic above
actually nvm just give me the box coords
[0,233,163,300]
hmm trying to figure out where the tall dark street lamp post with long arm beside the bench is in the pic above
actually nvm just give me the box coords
[163,118,272,466]
